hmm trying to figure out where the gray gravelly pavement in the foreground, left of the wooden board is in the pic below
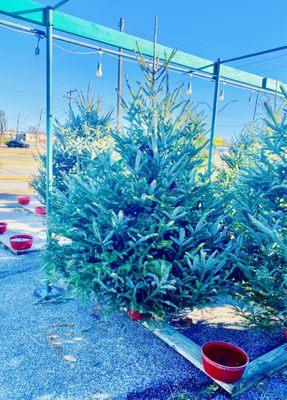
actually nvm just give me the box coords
[0,264,212,400]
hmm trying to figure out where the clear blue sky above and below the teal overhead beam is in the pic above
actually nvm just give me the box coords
[0,0,287,138]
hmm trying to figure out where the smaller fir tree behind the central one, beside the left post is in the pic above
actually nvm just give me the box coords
[32,87,112,202]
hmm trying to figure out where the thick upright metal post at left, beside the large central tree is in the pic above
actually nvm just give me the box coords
[45,7,54,234]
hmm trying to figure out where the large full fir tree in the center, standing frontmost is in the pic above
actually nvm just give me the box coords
[46,60,233,316]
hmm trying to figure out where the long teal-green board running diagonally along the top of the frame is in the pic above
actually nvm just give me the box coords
[0,0,287,90]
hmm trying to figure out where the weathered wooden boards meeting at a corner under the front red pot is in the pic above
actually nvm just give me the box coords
[143,321,287,397]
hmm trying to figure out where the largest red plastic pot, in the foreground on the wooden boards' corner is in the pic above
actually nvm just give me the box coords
[201,341,249,383]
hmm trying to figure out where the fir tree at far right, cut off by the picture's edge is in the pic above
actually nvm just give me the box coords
[232,89,287,326]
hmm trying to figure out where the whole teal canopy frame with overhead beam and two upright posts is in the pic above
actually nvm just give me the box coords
[0,0,287,217]
